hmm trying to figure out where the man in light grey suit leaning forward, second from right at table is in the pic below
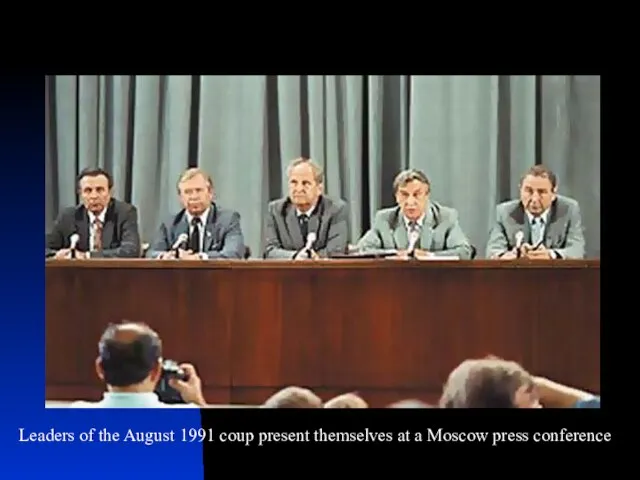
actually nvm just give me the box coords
[357,169,474,260]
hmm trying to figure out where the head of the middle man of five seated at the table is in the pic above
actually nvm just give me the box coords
[287,158,324,212]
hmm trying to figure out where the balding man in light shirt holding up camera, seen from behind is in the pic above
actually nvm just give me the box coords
[70,323,206,408]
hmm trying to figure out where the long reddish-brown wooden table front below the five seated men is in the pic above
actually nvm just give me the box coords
[46,259,600,406]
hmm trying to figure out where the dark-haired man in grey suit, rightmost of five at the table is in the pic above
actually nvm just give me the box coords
[486,165,585,260]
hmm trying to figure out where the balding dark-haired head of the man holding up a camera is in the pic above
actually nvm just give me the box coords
[96,322,162,392]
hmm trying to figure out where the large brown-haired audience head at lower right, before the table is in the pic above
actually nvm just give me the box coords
[440,358,541,408]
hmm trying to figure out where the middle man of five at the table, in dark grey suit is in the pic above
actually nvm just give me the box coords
[264,158,349,260]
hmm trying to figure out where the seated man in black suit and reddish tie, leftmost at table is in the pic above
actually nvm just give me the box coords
[45,168,141,258]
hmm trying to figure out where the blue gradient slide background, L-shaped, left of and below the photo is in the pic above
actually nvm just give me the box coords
[0,76,203,480]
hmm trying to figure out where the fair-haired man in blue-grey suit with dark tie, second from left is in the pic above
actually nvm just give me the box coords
[146,168,246,260]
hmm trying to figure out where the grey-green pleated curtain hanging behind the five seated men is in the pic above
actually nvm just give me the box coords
[45,75,600,258]
